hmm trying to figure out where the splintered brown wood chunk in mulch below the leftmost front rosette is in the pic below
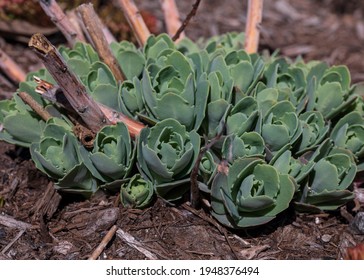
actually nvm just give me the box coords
[30,182,62,223]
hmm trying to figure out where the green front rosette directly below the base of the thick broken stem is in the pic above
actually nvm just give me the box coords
[89,123,135,187]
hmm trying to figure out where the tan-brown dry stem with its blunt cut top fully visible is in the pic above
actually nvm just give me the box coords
[77,3,125,81]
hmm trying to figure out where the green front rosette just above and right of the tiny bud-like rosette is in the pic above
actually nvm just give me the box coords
[137,119,200,201]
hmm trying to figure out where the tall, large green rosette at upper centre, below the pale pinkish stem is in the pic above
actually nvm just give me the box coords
[139,35,209,131]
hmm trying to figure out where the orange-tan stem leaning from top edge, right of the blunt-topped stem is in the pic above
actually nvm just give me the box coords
[118,0,150,46]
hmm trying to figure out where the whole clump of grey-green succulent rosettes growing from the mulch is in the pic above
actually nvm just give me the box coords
[0,33,364,228]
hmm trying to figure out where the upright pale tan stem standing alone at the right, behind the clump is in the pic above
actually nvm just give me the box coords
[245,0,263,53]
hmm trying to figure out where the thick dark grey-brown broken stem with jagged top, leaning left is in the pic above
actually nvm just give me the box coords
[29,33,111,133]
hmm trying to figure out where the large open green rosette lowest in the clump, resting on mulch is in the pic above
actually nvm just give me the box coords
[211,158,295,228]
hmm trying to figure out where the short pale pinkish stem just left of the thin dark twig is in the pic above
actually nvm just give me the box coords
[161,0,185,39]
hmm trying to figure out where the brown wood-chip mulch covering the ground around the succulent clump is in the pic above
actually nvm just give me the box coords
[0,0,364,259]
